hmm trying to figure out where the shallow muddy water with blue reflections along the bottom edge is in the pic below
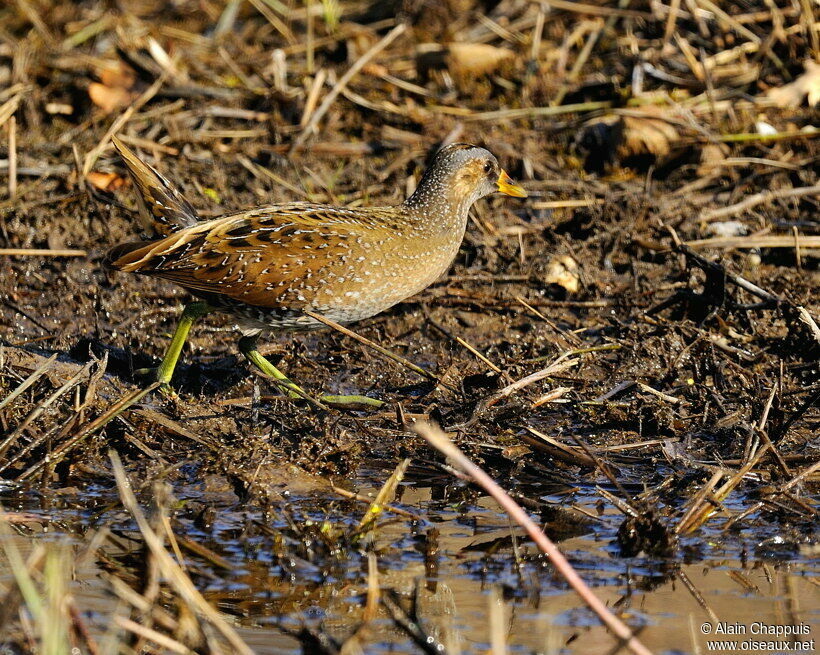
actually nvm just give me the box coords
[0,469,820,654]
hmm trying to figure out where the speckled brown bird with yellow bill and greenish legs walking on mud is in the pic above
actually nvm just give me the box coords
[103,136,527,407]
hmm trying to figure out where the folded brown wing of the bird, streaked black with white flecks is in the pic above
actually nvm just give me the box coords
[104,203,395,307]
